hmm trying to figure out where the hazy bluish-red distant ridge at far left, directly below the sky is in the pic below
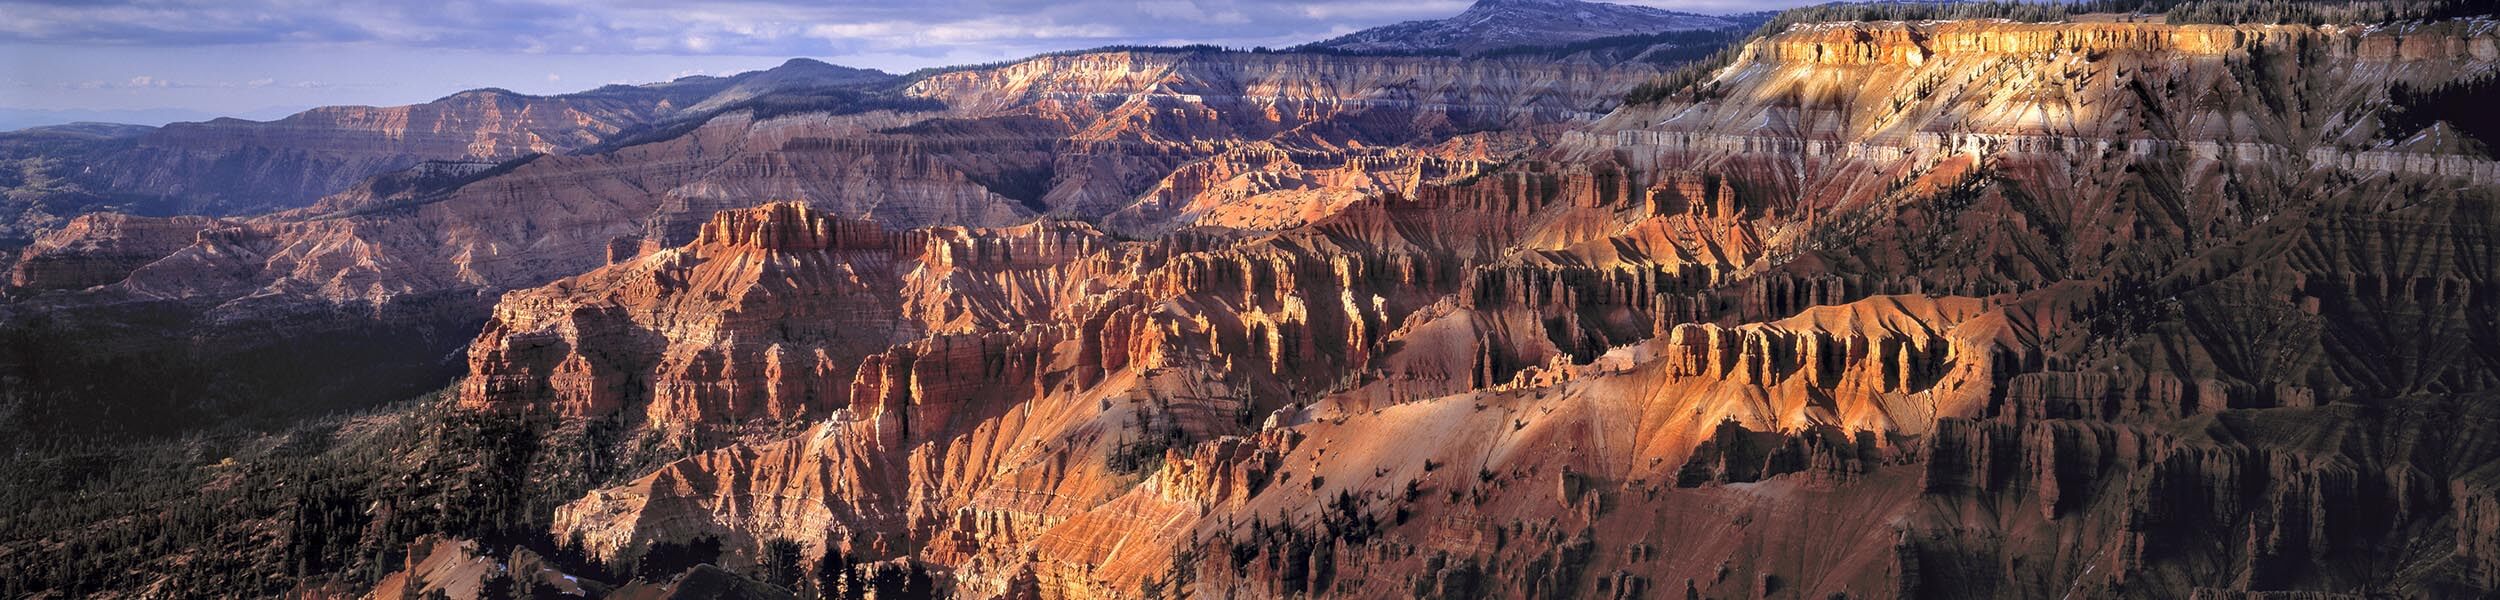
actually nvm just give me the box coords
[0,60,893,241]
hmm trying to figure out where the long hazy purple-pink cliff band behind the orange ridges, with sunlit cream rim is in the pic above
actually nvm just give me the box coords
[14,53,1655,310]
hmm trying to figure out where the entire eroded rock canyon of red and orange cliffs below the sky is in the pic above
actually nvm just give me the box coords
[0,0,2500,598]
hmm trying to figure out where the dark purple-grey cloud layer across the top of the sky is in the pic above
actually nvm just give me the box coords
[0,0,1800,55]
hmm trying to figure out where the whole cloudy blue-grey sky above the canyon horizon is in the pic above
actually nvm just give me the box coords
[0,0,1805,125]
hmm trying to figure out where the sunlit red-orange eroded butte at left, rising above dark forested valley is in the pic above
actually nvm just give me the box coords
[460,203,1108,428]
